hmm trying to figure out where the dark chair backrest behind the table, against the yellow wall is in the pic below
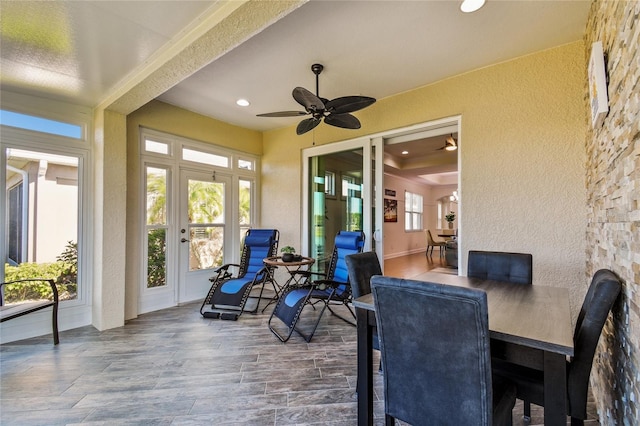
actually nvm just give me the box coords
[467,250,533,284]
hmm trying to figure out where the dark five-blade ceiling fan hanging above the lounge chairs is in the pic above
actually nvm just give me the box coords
[258,64,376,135]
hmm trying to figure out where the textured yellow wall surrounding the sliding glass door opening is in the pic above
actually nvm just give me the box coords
[262,42,586,314]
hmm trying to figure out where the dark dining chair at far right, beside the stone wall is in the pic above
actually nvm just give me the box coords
[494,269,622,426]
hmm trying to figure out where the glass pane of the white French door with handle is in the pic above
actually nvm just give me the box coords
[187,179,225,271]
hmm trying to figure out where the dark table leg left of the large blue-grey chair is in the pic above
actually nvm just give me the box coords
[356,308,373,426]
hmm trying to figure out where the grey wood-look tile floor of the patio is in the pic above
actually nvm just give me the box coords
[0,254,597,426]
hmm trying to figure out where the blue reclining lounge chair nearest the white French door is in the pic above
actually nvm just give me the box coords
[200,229,280,320]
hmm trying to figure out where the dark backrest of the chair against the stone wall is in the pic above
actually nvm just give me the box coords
[567,269,622,419]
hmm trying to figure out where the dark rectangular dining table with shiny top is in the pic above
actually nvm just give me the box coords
[353,272,574,426]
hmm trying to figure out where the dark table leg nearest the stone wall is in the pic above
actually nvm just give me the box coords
[544,351,567,426]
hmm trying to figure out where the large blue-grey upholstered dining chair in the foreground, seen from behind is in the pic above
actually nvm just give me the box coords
[371,276,516,425]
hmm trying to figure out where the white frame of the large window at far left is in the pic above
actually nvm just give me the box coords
[0,91,93,343]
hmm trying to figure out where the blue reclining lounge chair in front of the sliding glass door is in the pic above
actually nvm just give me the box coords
[269,231,364,342]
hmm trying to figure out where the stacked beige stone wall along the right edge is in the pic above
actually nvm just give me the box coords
[585,0,640,426]
